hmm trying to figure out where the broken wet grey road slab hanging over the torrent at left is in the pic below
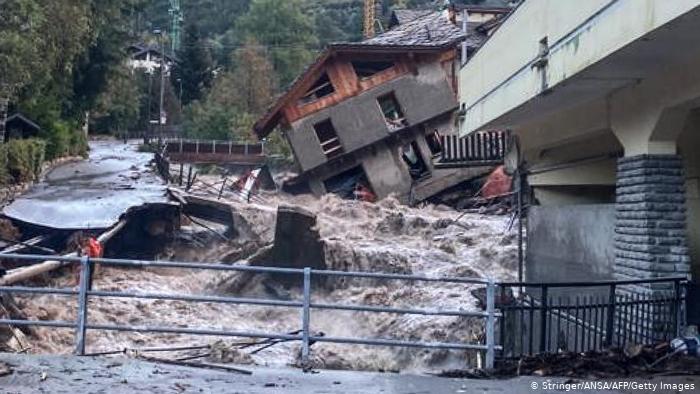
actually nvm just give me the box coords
[3,141,167,230]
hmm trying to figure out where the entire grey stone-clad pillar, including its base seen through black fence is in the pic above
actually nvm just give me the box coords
[613,154,690,340]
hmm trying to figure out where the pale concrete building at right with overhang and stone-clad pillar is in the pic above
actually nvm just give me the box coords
[460,0,700,304]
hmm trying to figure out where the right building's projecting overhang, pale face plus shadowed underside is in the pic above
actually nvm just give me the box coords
[460,0,700,135]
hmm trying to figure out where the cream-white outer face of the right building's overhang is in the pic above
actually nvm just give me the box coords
[460,0,700,134]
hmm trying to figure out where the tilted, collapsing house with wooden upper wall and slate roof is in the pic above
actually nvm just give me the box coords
[255,11,508,202]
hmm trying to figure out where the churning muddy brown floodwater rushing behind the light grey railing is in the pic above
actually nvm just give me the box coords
[12,196,517,370]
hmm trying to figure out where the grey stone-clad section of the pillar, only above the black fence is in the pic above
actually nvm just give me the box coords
[614,155,690,279]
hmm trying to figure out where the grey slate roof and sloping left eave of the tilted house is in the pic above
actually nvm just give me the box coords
[253,12,470,138]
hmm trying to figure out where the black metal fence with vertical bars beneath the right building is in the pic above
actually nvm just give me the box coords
[496,277,687,358]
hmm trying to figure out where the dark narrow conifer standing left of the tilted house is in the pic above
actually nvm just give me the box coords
[171,23,214,105]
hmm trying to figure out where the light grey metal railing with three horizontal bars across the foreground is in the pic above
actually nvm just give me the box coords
[0,254,501,368]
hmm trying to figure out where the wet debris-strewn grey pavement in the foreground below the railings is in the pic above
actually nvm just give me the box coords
[0,353,700,394]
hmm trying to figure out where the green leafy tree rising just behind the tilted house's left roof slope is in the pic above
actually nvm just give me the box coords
[236,0,318,86]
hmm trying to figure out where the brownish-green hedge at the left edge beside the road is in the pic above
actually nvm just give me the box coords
[0,139,46,185]
